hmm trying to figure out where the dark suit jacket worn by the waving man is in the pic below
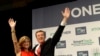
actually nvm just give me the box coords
[33,25,65,56]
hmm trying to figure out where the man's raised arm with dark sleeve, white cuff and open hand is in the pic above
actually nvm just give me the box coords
[52,8,70,46]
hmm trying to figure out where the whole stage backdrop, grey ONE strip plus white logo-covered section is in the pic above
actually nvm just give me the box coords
[32,0,100,56]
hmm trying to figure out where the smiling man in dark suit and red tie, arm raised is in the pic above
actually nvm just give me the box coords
[33,8,70,56]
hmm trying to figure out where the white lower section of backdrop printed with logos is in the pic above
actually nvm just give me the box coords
[32,21,100,56]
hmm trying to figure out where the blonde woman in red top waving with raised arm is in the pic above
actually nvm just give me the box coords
[8,18,35,56]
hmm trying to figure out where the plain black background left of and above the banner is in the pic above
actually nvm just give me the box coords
[0,0,76,56]
